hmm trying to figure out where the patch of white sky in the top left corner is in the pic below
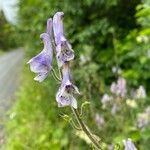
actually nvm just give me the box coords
[0,0,18,24]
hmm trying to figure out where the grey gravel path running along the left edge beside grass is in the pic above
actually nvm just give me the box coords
[0,48,24,149]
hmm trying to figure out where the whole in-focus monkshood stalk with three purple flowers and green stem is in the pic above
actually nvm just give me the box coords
[28,12,103,150]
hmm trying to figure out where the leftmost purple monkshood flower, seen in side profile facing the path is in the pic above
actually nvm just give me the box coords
[28,19,53,82]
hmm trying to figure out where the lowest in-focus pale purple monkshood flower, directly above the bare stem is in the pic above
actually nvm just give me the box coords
[56,64,79,109]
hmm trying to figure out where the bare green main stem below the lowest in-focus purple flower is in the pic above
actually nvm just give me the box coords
[72,108,103,150]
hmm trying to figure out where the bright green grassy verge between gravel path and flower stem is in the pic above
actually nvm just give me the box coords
[6,69,89,150]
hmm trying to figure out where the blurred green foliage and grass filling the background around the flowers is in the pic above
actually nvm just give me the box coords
[0,0,150,150]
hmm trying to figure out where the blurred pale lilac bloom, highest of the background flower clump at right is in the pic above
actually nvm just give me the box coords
[110,77,127,97]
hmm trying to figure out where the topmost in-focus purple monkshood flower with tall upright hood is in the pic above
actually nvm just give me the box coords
[53,12,74,67]
